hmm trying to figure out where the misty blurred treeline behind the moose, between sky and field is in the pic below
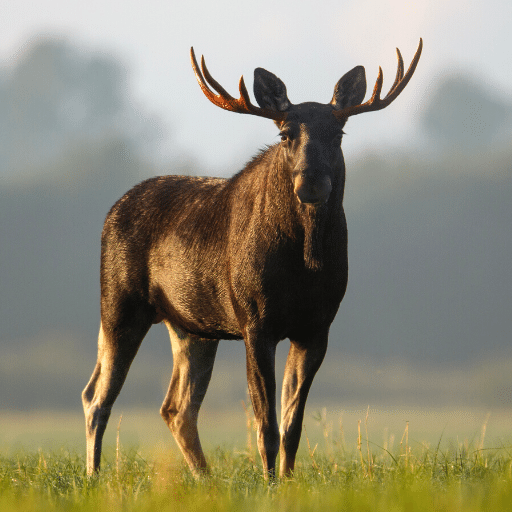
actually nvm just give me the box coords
[0,39,512,420]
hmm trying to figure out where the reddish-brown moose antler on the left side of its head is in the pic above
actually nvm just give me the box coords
[190,47,287,122]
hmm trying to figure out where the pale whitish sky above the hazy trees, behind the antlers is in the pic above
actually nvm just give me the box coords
[0,0,512,175]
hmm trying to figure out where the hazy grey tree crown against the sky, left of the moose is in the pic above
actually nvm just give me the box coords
[0,39,161,175]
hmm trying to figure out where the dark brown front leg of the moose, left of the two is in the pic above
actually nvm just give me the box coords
[245,339,279,479]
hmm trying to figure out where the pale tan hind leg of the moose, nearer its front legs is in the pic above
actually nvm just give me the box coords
[160,324,219,477]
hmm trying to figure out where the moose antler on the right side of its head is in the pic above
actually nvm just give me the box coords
[334,38,423,119]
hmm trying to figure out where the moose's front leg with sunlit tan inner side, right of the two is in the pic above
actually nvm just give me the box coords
[279,333,327,477]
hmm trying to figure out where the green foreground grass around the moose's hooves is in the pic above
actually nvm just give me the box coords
[0,411,512,512]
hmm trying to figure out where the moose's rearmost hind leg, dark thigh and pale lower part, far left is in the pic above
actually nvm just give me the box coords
[82,323,151,475]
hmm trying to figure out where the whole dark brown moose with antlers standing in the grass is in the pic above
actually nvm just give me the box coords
[82,39,423,479]
